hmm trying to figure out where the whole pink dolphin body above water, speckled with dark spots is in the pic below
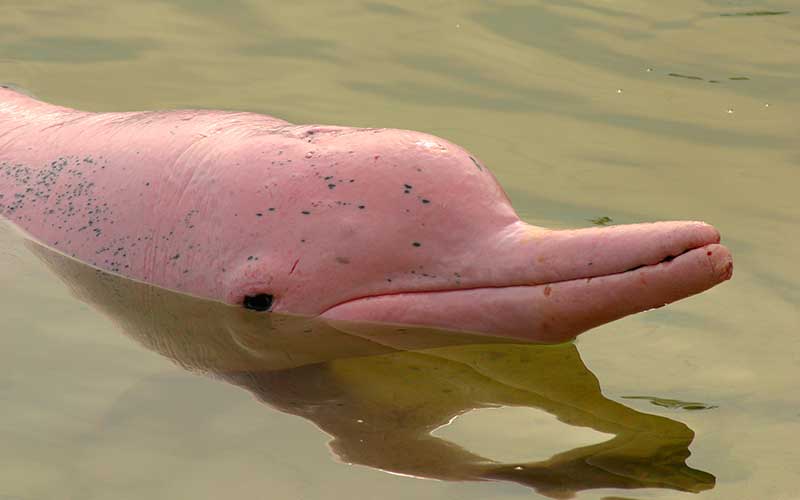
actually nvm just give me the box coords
[0,88,732,342]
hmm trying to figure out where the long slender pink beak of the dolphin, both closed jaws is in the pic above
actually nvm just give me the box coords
[322,222,733,343]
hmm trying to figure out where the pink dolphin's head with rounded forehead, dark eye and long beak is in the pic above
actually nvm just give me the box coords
[220,126,732,342]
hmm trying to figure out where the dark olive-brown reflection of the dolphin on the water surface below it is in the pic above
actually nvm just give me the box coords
[26,237,715,498]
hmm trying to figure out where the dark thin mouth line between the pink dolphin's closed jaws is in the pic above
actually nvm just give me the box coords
[319,242,717,316]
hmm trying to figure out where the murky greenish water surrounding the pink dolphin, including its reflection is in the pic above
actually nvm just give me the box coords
[0,0,800,500]
